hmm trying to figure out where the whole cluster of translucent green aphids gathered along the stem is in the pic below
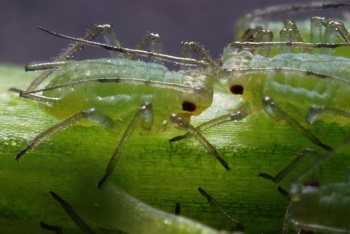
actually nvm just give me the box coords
[8,1,350,233]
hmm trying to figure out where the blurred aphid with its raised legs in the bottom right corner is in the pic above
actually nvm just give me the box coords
[263,140,350,233]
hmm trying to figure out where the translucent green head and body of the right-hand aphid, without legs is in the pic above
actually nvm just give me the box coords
[220,51,350,123]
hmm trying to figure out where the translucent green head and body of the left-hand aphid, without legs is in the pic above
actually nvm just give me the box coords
[41,58,213,132]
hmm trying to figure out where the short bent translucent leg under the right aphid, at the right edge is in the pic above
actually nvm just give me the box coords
[306,105,350,124]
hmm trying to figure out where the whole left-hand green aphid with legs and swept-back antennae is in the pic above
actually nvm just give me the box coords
[11,25,229,187]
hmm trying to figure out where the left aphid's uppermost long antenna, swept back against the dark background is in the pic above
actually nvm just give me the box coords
[38,26,209,67]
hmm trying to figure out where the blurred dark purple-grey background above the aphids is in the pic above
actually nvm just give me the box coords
[0,0,344,64]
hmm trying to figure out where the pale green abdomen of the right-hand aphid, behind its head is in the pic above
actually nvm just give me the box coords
[250,54,350,119]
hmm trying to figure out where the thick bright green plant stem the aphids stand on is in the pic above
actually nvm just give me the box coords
[0,65,350,233]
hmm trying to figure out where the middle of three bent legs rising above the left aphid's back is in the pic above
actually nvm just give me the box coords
[129,33,163,62]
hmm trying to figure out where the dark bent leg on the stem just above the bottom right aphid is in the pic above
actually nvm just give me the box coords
[259,148,318,184]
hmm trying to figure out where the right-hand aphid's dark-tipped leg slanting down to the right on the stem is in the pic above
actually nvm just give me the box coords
[263,97,333,151]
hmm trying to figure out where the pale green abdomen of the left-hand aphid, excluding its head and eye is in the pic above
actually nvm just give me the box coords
[43,59,183,122]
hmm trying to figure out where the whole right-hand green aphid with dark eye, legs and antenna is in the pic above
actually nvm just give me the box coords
[172,0,350,154]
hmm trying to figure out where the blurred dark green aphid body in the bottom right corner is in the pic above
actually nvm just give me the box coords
[287,183,350,233]
